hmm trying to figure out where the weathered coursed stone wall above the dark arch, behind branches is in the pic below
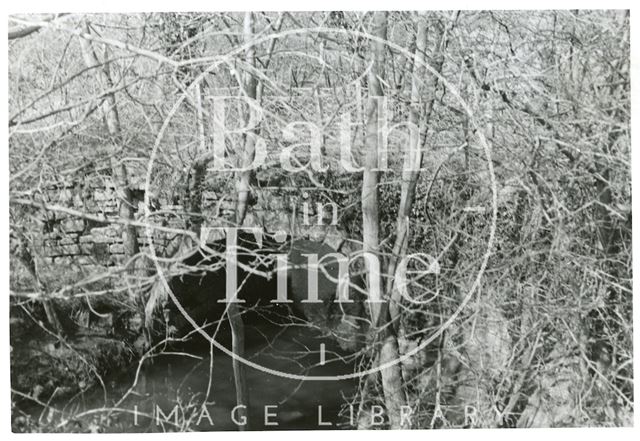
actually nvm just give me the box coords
[37,174,342,266]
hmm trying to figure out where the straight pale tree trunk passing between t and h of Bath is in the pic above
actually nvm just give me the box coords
[362,12,407,429]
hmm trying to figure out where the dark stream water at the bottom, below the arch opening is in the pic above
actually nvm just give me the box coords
[30,326,356,432]
